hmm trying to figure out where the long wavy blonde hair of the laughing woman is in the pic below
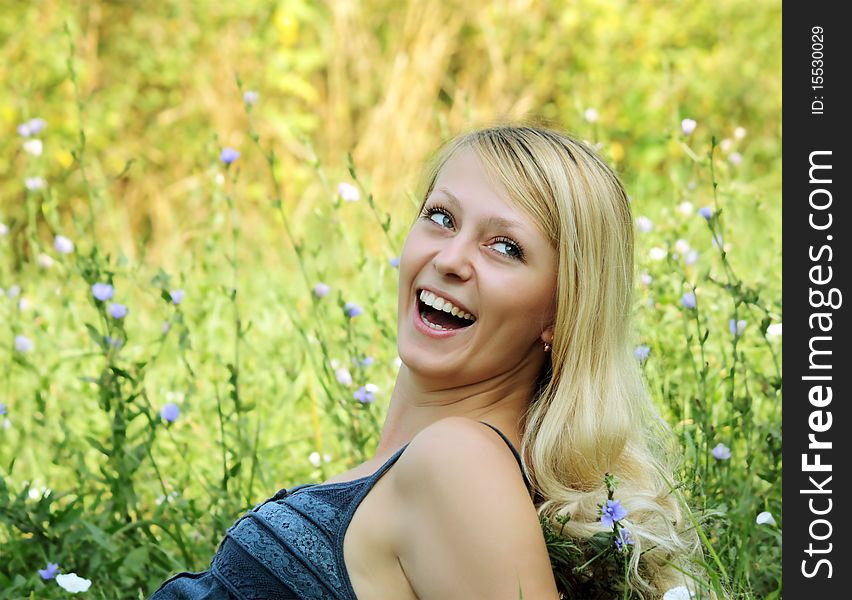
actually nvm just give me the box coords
[418,124,701,598]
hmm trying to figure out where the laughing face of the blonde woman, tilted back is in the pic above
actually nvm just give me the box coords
[397,148,558,386]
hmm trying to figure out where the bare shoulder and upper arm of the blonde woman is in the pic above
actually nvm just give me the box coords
[393,417,558,600]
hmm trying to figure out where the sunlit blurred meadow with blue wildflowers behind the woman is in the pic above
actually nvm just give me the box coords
[0,0,781,598]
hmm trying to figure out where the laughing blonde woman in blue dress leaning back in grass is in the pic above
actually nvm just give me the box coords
[152,126,697,600]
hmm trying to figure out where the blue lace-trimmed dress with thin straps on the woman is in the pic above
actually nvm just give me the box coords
[149,421,530,600]
